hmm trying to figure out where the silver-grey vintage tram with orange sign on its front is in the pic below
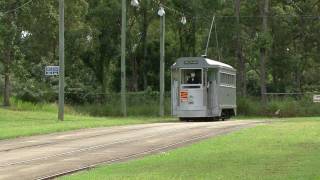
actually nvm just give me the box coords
[171,57,237,120]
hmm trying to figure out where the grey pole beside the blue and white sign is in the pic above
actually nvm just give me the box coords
[58,0,64,121]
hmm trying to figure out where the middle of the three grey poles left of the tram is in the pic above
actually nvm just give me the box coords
[121,0,127,116]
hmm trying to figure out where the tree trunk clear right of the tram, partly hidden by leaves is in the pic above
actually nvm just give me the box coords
[260,0,269,105]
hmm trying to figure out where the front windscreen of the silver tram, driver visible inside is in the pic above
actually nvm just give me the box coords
[181,69,202,84]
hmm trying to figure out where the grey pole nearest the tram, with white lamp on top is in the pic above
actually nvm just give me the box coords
[158,7,165,116]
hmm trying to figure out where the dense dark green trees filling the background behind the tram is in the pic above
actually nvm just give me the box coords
[0,0,320,105]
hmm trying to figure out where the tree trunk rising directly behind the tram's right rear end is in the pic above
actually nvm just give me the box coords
[235,0,247,96]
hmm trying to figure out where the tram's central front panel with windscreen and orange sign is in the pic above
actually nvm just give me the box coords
[179,69,204,110]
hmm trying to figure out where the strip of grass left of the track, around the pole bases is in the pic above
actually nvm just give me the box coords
[0,108,176,140]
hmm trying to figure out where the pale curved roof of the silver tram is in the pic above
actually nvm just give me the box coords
[172,57,235,70]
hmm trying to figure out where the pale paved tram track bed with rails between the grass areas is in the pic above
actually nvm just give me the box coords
[0,121,260,179]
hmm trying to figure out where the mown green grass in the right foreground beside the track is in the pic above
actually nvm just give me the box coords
[62,118,320,180]
